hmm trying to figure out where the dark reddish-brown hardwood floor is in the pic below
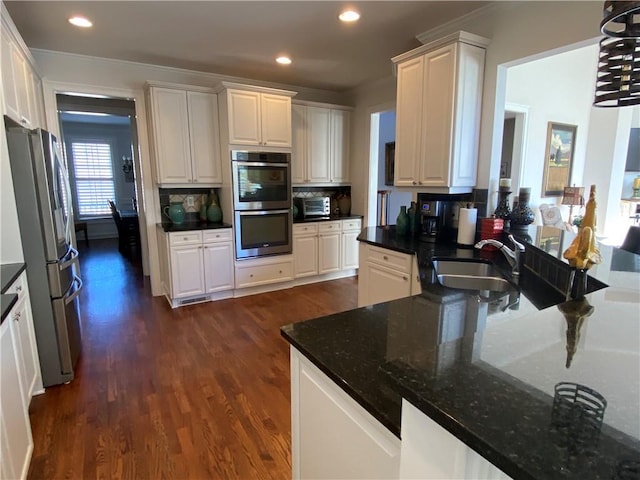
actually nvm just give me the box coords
[29,241,357,480]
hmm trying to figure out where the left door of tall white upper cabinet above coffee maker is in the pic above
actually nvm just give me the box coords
[393,57,424,187]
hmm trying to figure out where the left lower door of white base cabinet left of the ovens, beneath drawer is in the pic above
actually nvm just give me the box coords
[171,245,204,298]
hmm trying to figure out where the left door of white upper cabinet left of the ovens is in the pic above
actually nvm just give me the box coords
[151,87,191,183]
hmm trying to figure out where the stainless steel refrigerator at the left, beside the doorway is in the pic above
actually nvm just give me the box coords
[4,116,82,387]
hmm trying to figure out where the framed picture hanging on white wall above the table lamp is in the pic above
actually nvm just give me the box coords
[542,122,577,197]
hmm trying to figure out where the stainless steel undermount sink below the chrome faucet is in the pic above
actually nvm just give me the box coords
[433,259,513,292]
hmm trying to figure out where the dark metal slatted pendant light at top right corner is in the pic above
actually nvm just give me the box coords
[593,1,640,107]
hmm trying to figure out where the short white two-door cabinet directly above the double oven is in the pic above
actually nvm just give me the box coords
[215,82,295,148]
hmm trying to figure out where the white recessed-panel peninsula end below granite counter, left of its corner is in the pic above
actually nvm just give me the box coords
[291,347,401,479]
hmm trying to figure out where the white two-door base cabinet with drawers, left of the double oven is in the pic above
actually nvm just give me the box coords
[158,227,234,307]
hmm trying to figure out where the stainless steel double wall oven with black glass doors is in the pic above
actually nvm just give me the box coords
[231,150,293,259]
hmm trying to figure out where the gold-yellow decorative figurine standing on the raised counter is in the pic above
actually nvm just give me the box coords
[562,185,602,270]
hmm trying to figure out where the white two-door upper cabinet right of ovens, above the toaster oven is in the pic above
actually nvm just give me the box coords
[291,102,351,185]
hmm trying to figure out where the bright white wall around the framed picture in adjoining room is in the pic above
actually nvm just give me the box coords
[506,45,598,208]
